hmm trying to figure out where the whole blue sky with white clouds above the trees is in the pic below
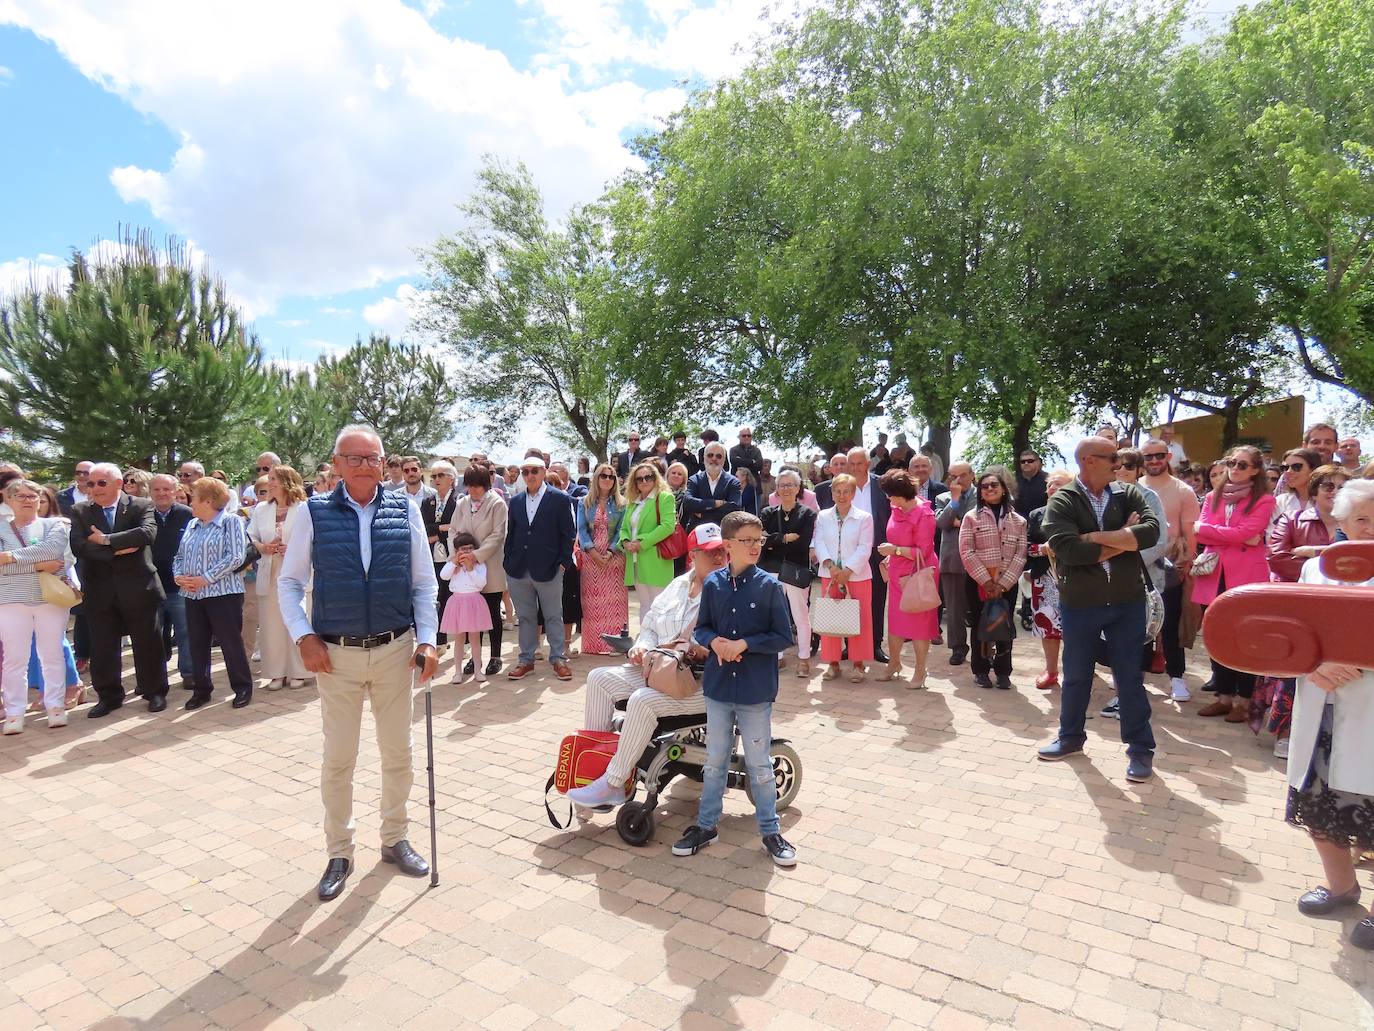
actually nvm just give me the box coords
[0,0,1258,456]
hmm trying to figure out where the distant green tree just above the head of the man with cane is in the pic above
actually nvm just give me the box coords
[314,333,453,455]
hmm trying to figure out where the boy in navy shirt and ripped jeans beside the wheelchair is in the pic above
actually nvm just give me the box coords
[673,511,797,866]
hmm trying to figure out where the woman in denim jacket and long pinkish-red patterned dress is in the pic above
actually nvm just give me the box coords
[577,462,629,656]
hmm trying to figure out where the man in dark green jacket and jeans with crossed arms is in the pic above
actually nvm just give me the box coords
[1040,437,1161,784]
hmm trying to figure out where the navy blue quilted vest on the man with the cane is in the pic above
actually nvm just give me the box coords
[306,484,414,636]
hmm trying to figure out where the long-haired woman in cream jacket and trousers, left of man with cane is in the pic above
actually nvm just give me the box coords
[249,466,311,691]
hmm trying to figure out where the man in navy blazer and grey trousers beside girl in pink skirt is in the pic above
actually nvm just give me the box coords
[504,456,574,680]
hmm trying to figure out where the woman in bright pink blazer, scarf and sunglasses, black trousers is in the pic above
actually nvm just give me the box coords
[1193,445,1275,723]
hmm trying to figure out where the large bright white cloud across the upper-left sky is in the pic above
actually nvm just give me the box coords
[0,0,761,315]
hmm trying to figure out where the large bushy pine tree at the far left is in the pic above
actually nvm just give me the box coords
[0,235,269,469]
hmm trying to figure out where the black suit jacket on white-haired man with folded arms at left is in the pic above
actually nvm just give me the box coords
[71,494,166,613]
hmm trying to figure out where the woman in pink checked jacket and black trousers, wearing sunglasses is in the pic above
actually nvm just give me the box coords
[959,466,1026,691]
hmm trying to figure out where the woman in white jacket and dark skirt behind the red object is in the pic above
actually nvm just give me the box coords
[1285,480,1374,949]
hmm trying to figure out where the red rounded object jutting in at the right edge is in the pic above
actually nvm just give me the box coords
[1202,540,1374,676]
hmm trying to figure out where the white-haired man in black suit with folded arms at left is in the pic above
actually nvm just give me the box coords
[71,462,168,719]
